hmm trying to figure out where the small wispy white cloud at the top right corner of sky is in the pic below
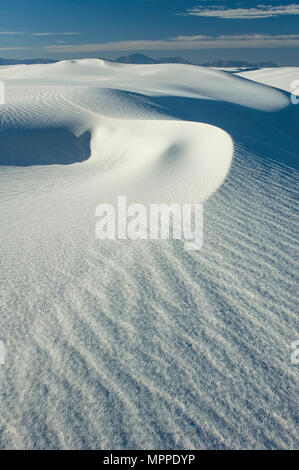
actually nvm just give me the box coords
[179,3,299,19]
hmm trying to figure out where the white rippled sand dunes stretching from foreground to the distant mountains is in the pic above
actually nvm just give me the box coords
[0,59,299,449]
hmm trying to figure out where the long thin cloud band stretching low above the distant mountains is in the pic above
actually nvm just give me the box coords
[45,34,299,53]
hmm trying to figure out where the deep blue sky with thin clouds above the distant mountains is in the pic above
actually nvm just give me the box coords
[0,0,299,65]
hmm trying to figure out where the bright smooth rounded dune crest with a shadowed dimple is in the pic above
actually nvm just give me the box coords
[89,116,233,202]
